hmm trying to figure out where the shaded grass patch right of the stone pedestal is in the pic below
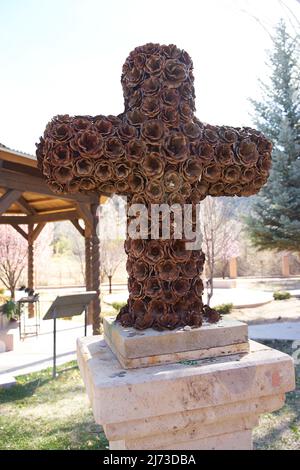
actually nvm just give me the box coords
[254,340,300,450]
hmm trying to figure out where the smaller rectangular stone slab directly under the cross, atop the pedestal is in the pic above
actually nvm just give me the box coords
[103,317,249,369]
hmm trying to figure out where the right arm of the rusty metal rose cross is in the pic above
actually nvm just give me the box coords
[193,121,272,198]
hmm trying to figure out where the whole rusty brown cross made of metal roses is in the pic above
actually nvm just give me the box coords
[37,44,272,330]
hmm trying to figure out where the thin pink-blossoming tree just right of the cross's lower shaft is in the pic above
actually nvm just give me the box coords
[200,197,241,305]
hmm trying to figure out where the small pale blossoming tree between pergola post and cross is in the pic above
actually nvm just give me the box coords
[100,240,126,294]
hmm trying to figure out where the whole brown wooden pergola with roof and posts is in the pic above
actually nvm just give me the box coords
[0,144,100,334]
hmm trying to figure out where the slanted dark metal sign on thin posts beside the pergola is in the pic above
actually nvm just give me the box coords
[43,291,97,378]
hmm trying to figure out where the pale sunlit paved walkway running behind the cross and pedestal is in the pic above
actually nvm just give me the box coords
[0,286,300,386]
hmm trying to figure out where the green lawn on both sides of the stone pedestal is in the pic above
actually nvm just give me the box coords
[0,341,300,450]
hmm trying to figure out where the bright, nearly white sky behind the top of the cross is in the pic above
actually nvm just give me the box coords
[0,0,300,153]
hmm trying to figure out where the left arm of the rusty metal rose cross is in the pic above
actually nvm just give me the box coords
[36,115,141,194]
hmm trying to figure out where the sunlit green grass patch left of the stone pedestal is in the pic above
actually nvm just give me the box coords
[0,362,108,450]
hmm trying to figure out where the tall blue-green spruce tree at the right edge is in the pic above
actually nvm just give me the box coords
[246,21,300,253]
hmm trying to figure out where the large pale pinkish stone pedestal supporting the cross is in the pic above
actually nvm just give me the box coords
[78,322,295,450]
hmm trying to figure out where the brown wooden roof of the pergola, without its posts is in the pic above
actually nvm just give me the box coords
[0,144,99,224]
